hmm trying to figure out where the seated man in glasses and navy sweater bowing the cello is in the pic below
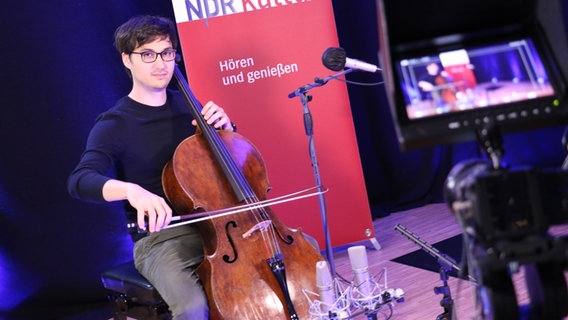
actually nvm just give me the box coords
[68,16,233,319]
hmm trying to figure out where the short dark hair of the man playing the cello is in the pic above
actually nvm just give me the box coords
[114,15,178,54]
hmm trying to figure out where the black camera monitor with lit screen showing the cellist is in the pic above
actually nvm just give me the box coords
[378,1,568,150]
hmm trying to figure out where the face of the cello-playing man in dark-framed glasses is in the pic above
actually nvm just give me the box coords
[122,37,175,91]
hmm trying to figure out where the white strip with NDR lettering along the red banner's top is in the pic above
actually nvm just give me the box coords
[172,0,311,23]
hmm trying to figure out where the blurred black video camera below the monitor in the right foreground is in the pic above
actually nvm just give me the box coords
[444,160,568,246]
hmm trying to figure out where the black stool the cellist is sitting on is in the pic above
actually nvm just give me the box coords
[101,261,172,320]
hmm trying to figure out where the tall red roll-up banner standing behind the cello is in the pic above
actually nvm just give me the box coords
[173,0,374,248]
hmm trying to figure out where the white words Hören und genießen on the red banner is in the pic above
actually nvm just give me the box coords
[219,58,298,86]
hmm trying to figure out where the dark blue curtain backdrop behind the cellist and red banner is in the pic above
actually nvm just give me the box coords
[0,0,568,319]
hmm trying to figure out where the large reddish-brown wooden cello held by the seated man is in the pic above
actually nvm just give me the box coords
[162,65,323,320]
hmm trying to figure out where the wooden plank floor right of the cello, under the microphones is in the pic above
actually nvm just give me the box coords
[328,204,568,320]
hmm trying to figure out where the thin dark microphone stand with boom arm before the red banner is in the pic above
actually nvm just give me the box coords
[288,69,353,278]
